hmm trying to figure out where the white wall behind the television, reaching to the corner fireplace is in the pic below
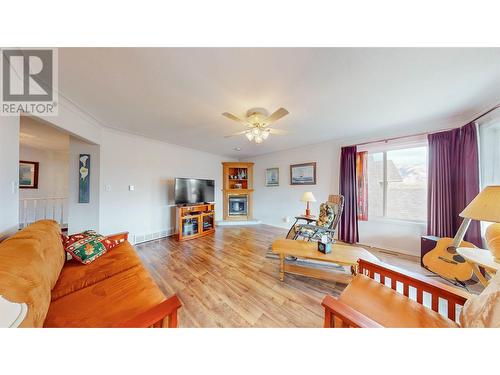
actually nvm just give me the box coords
[100,130,236,241]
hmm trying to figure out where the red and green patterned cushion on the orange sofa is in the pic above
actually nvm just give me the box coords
[64,230,125,264]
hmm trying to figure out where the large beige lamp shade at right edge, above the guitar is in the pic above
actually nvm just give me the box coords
[460,185,500,223]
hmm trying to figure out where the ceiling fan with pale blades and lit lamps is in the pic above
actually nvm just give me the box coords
[222,108,289,144]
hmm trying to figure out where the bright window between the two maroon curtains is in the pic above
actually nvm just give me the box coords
[366,143,427,221]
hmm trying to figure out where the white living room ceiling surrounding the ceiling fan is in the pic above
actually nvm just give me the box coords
[59,48,500,157]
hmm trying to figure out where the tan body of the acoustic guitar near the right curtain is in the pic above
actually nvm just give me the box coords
[422,238,475,282]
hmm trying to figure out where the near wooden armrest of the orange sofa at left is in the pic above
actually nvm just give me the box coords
[118,294,182,328]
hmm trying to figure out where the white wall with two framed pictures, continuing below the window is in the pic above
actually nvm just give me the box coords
[246,138,426,255]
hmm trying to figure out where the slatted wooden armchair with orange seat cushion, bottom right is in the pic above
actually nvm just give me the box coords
[322,259,470,328]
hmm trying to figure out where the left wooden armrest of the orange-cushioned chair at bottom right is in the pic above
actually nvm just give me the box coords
[321,296,382,328]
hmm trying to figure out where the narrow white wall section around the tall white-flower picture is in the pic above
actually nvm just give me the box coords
[68,136,100,233]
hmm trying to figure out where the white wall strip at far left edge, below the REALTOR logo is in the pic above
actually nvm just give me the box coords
[0,116,19,239]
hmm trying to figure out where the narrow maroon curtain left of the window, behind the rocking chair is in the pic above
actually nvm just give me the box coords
[339,146,359,243]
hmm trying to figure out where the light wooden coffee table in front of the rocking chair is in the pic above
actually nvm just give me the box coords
[272,239,379,283]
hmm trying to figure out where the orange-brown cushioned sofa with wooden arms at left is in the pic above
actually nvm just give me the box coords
[0,220,181,327]
